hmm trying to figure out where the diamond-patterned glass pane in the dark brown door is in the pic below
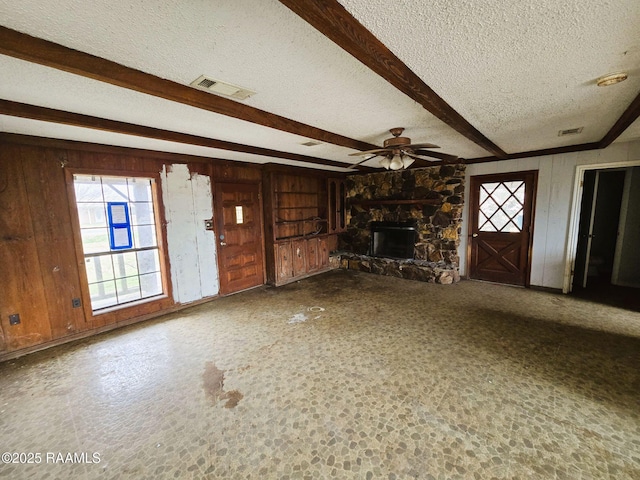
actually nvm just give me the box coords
[478,181,525,233]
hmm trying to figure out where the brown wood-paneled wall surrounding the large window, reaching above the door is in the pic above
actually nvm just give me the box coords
[0,134,262,359]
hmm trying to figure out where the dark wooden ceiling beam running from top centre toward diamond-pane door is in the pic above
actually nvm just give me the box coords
[280,0,507,158]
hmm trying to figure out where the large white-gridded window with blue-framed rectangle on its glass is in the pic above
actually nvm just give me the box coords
[73,174,166,313]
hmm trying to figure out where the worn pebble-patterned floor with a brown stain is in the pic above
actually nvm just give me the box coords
[0,271,640,479]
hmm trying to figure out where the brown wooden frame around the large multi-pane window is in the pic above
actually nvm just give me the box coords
[65,168,174,326]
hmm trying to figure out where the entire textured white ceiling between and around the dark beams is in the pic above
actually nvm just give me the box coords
[0,0,640,168]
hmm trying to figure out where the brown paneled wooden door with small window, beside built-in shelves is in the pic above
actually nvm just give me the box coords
[214,183,264,295]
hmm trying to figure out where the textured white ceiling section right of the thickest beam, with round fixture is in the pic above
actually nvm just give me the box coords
[341,0,640,153]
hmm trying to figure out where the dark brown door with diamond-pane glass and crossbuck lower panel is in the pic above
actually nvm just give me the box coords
[469,171,537,286]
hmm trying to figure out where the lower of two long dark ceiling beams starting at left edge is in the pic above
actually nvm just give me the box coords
[0,99,366,170]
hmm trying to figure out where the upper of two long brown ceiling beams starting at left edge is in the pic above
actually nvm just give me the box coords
[0,26,378,150]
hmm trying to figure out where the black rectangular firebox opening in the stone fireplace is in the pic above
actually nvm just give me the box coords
[369,222,417,259]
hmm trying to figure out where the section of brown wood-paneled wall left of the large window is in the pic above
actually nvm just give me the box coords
[0,141,87,350]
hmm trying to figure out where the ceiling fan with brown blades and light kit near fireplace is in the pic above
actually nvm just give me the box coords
[349,128,459,170]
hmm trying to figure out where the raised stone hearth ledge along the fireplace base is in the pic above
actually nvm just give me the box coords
[340,253,460,285]
